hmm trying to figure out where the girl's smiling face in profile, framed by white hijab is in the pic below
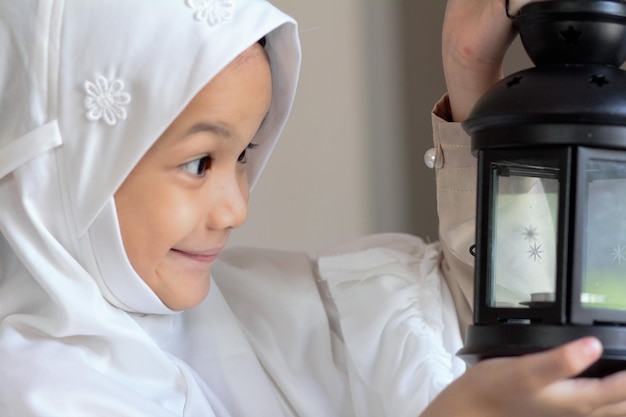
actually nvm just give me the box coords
[115,45,272,310]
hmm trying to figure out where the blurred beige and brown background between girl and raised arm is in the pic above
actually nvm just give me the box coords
[230,0,530,254]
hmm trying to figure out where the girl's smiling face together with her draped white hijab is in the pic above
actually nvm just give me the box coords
[0,0,299,417]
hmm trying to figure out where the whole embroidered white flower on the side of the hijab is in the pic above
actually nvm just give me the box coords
[85,76,130,126]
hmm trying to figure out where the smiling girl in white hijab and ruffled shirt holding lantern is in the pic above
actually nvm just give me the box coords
[0,0,626,417]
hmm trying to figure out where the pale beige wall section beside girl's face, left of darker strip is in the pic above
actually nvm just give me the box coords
[231,0,372,251]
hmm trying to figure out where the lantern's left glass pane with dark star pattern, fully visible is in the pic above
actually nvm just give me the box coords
[487,160,556,308]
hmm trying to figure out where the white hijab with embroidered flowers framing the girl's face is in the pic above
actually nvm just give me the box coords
[0,0,300,417]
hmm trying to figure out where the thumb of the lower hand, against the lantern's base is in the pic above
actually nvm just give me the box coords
[522,337,602,389]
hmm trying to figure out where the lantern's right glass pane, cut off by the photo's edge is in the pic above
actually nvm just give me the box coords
[580,159,626,310]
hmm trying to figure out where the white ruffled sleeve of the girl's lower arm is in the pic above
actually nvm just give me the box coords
[317,234,465,417]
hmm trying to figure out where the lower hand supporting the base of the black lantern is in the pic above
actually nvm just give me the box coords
[421,337,626,417]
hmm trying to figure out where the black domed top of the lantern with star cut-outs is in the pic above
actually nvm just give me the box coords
[463,0,626,151]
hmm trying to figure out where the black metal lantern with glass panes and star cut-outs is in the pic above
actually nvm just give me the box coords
[459,0,626,376]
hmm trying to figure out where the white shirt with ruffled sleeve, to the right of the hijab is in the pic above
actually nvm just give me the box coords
[213,234,465,417]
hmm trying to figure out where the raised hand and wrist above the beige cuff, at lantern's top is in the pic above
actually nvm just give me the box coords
[442,0,540,121]
